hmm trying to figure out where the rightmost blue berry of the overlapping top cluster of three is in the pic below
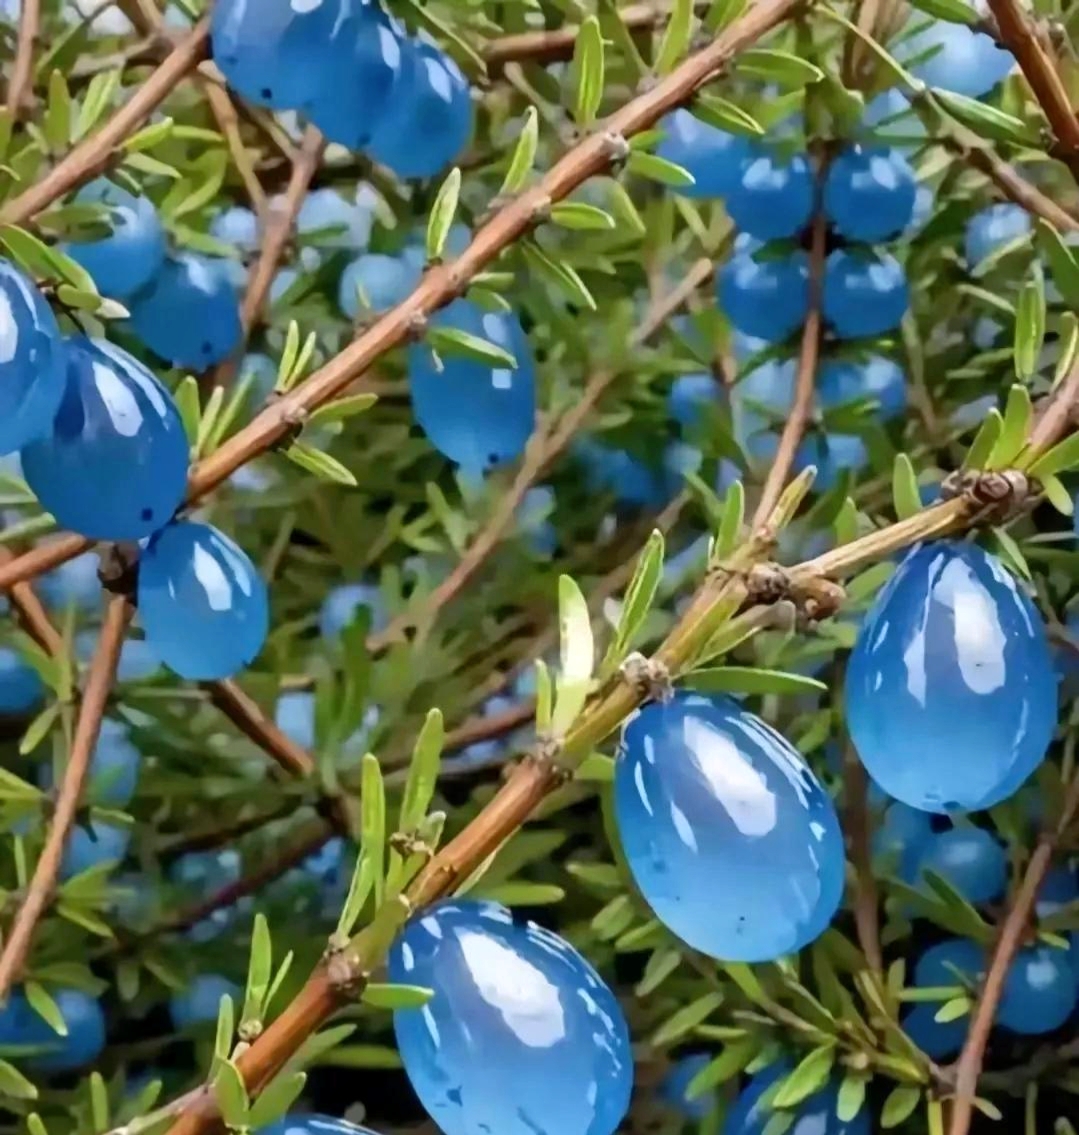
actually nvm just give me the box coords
[368,39,472,177]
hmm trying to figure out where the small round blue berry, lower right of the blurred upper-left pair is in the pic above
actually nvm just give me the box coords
[130,253,243,370]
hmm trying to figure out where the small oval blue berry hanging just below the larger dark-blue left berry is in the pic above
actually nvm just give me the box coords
[138,522,269,681]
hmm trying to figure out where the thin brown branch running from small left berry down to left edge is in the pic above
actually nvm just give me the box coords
[0,596,134,1000]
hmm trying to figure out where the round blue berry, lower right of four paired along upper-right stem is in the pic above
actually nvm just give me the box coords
[821,249,910,339]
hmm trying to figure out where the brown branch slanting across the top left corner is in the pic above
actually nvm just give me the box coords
[0,18,210,227]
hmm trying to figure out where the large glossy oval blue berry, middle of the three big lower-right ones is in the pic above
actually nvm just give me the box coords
[615,692,844,961]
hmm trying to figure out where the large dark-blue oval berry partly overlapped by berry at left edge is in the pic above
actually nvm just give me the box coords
[23,336,188,540]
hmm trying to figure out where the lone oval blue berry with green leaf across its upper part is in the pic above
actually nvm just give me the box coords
[408,300,536,472]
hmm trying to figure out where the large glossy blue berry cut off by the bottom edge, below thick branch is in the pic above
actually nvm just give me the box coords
[388,899,633,1135]
